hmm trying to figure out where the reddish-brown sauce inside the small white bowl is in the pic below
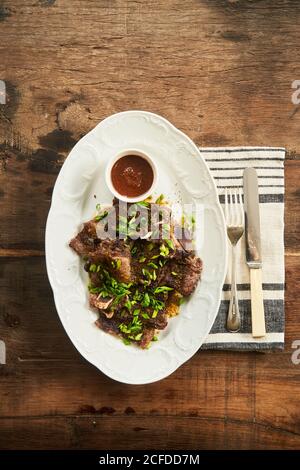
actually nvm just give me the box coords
[111,155,154,197]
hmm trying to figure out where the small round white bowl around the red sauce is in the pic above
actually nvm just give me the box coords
[105,148,157,202]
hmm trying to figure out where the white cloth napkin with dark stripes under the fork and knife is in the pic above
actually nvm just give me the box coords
[200,147,285,350]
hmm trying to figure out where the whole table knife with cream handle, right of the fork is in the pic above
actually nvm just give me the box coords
[244,168,266,338]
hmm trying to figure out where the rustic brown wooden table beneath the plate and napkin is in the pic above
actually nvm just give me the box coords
[0,0,300,449]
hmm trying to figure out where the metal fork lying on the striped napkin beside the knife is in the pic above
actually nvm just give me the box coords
[225,189,244,332]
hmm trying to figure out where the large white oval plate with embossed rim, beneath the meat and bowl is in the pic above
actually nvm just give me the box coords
[46,111,227,384]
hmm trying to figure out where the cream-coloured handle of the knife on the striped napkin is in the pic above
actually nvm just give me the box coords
[250,268,266,338]
